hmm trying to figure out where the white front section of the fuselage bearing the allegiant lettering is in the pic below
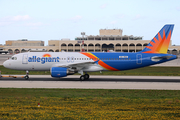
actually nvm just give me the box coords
[3,52,106,72]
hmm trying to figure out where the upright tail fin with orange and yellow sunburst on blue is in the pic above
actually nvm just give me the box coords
[141,24,174,54]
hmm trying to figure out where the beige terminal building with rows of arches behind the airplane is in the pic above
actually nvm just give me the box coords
[0,29,180,54]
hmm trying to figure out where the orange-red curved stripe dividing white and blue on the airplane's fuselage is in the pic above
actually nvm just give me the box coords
[80,52,119,71]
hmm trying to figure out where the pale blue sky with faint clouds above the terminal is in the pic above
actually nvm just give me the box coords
[0,0,180,45]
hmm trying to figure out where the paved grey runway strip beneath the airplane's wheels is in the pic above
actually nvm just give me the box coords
[0,75,180,90]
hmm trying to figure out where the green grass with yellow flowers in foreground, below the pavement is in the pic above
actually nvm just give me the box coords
[0,88,180,120]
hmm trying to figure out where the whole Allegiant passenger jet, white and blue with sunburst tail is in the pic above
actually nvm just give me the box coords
[3,25,177,80]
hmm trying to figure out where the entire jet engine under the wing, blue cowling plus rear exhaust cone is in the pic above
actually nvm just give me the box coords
[50,67,77,77]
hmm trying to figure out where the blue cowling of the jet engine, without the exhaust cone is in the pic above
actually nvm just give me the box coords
[51,67,68,77]
